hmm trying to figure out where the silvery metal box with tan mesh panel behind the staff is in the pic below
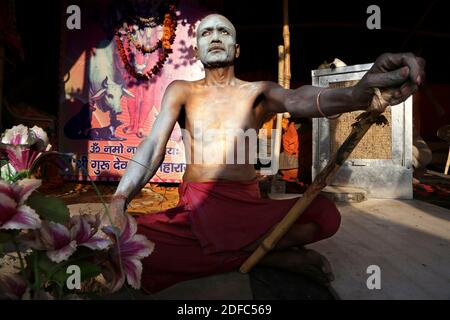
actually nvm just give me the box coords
[312,64,413,199]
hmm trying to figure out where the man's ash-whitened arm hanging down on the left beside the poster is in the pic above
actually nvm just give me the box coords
[109,81,185,226]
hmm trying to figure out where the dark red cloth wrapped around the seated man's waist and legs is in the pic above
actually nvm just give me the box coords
[137,180,340,293]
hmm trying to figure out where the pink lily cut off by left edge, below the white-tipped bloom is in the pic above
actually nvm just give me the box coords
[0,179,41,229]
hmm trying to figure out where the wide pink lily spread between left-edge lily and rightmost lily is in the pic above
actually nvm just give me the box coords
[23,215,111,263]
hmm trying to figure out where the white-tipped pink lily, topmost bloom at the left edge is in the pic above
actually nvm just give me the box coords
[0,124,51,172]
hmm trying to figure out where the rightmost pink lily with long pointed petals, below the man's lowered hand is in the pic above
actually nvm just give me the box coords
[103,215,155,292]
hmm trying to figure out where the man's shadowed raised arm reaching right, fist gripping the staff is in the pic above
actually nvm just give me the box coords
[263,53,425,118]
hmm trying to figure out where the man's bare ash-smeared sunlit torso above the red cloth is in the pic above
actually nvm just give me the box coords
[183,78,270,182]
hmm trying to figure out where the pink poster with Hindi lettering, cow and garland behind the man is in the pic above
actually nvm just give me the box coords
[59,0,207,182]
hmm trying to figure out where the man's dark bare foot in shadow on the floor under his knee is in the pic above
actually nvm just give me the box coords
[261,248,334,285]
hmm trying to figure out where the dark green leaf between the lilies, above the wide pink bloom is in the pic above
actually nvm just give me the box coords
[27,192,70,223]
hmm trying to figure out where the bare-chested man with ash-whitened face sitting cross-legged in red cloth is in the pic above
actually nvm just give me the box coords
[110,14,424,292]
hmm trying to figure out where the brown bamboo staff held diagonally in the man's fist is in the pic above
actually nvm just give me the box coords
[240,89,389,273]
